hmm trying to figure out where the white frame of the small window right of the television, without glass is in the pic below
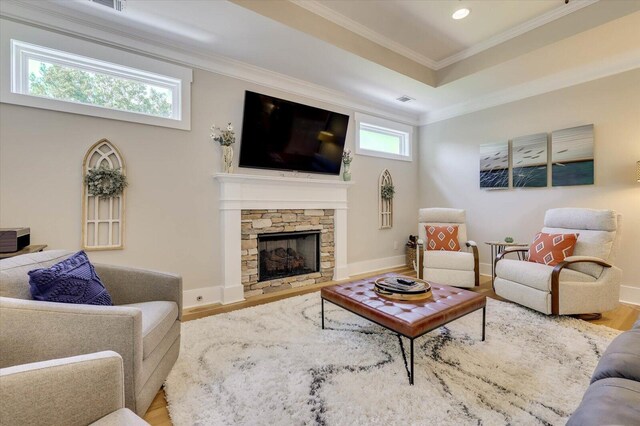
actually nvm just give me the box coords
[355,112,413,161]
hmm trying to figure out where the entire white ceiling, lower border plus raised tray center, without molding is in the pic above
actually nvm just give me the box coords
[0,0,640,123]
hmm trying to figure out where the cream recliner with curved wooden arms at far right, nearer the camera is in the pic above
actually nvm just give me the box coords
[494,208,622,315]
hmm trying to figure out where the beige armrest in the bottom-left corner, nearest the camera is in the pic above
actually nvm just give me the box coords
[0,351,124,425]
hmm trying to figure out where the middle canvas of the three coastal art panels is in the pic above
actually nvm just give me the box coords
[511,133,547,188]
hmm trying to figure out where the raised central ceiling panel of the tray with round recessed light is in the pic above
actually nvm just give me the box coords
[297,0,566,62]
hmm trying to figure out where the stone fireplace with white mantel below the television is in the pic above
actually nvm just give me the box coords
[214,173,353,304]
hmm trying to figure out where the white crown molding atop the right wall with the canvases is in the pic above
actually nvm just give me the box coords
[420,49,640,126]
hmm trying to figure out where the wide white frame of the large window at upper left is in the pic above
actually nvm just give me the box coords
[0,20,193,130]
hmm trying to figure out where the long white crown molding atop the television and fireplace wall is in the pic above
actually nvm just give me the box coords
[0,0,418,126]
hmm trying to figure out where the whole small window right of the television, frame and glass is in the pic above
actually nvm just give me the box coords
[356,113,413,161]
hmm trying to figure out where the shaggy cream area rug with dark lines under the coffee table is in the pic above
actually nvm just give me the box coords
[165,293,619,426]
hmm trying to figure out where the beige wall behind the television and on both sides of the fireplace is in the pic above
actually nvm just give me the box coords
[0,65,418,305]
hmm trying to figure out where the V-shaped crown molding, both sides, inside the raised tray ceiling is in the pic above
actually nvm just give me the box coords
[289,0,599,71]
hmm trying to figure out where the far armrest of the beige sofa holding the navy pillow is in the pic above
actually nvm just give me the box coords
[94,264,182,319]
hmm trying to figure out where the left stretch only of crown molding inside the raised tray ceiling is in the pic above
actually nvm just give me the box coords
[289,0,438,70]
